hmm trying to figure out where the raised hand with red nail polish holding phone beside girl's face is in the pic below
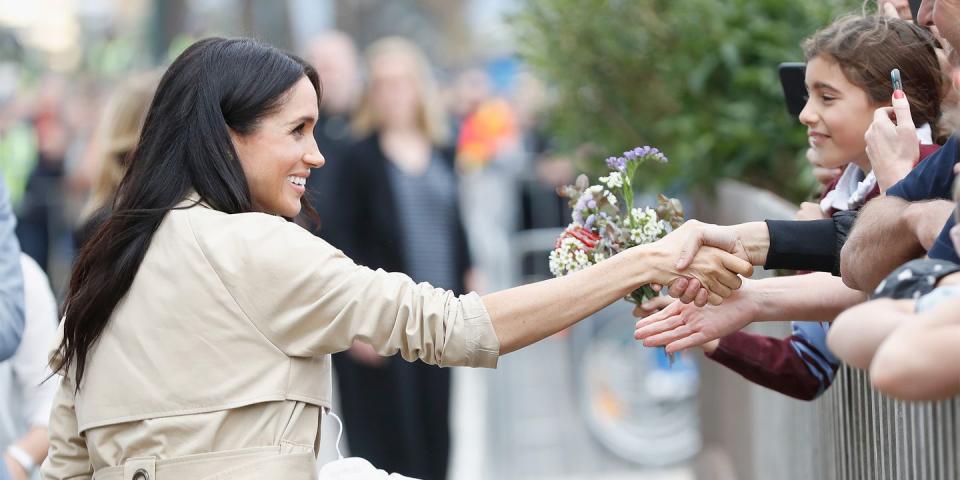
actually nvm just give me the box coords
[863,90,920,193]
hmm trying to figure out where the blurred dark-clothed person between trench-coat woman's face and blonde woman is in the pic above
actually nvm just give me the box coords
[302,31,362,243]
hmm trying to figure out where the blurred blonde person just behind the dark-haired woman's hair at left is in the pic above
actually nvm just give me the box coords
[74,72,160,250]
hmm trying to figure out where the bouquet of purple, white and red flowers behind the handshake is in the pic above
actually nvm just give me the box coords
[550,146,683,303]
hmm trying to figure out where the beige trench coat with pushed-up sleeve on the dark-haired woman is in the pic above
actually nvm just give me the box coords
[42,202,499,480]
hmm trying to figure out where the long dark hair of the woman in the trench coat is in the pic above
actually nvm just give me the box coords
[52,38,320,389]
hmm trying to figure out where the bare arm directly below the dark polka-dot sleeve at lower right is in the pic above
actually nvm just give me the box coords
[827,299,914,369]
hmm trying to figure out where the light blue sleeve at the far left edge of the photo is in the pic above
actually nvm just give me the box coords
[0,175,24,361]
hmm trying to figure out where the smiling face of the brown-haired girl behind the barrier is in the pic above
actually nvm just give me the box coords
[800,55,880,171]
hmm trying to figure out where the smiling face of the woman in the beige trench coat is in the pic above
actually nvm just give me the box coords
[231,77,324,217]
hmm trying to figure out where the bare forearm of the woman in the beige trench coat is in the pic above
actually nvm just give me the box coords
[483,246,654,355]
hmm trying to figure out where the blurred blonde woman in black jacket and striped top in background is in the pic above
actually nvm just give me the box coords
[332,37,471,480]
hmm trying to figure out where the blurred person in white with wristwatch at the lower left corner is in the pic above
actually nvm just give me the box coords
[0,254,59,480]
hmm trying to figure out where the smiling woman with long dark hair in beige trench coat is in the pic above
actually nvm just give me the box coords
[43,38,751,480]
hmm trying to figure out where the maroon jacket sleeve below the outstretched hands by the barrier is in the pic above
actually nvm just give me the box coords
[706,332,820,400]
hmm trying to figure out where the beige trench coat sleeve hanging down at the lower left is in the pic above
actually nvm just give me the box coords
[40,376,93,480]
